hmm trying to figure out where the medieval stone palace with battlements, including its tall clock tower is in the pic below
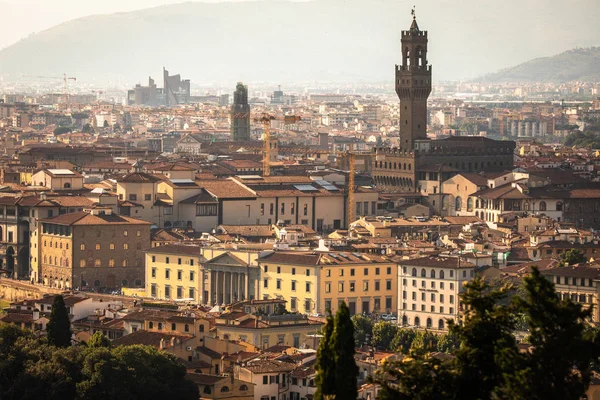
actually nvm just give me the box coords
[372,10,516,192]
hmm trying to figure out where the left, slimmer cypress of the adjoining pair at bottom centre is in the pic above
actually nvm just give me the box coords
[315,312,335,400]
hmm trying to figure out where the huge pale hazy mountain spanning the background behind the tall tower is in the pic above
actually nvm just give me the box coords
[0,0,600,83]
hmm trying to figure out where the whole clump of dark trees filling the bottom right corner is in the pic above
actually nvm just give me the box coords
[373,268,600,400]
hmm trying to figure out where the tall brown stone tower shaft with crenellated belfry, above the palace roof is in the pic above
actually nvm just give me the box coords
[396,9,431,150]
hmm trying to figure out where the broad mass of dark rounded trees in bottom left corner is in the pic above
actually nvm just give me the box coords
[0,326,199,400]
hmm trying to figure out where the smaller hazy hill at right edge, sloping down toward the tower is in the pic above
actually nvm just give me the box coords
[479,47,600,83]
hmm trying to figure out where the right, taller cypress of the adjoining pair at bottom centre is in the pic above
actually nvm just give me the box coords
[331,303,358,400]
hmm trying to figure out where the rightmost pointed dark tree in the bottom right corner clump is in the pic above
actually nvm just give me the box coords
[508,268,600,400]
